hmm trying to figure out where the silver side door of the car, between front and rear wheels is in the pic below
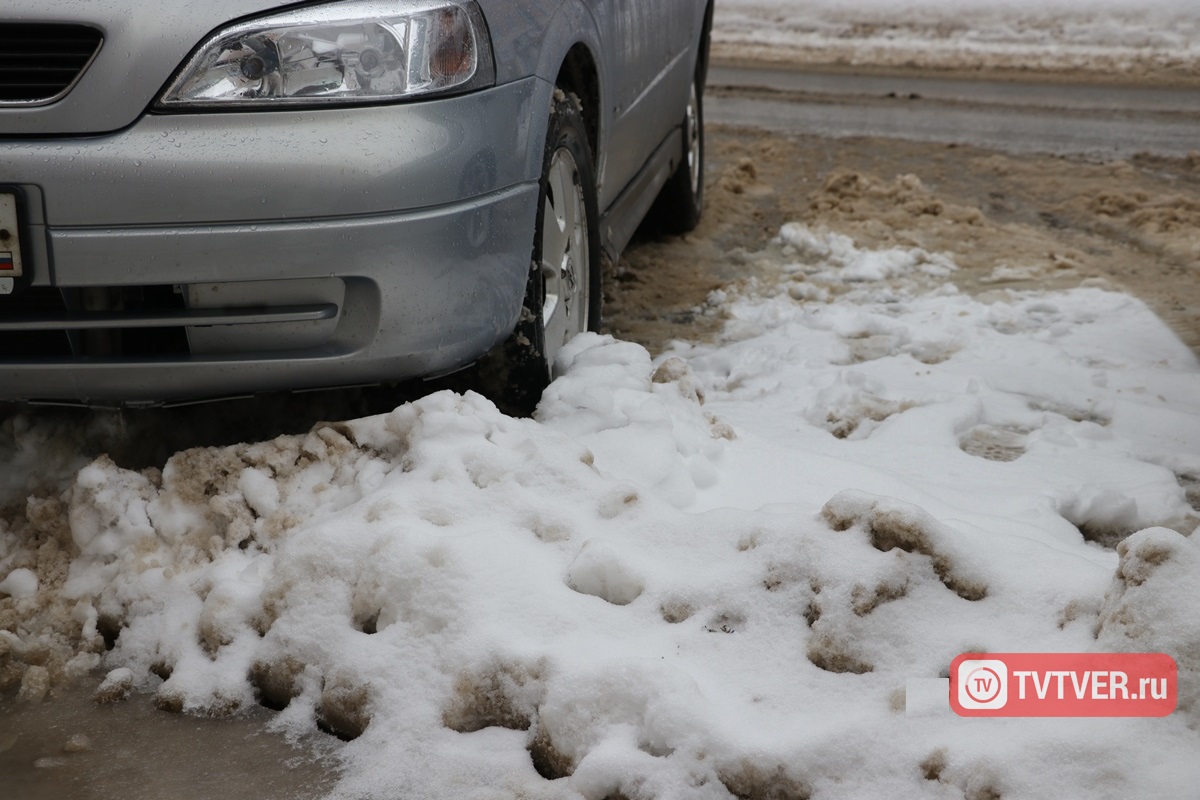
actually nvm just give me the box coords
[592,0,697,209]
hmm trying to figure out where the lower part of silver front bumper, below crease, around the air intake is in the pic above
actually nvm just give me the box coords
[0,184,538,405]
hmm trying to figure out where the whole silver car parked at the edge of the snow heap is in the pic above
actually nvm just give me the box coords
[0,0,712,405]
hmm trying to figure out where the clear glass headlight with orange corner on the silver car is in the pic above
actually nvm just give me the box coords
[158,0,496,108]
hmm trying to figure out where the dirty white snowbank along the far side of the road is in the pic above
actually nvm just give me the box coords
[713,0,1200,78]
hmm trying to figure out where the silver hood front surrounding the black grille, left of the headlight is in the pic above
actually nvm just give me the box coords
[0,0,343,136]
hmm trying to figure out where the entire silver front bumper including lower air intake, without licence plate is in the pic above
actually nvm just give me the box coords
[0,79,552,404]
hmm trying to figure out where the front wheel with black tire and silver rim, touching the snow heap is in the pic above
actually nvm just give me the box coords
[481,89,601,416]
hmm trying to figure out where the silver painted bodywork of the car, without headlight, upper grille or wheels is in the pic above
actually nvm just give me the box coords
[0,0,706,404]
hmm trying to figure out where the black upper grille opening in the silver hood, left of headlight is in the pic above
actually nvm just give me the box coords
[0,23,101,104]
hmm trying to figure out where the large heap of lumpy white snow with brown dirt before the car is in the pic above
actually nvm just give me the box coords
[0,224,1200,800]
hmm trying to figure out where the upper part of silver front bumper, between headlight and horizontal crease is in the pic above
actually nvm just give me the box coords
[0,78,553,228]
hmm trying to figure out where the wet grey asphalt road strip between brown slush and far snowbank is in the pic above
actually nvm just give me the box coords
[704,65,1200,158]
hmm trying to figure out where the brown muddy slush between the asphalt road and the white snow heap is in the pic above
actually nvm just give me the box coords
[606,126,1200,354]
